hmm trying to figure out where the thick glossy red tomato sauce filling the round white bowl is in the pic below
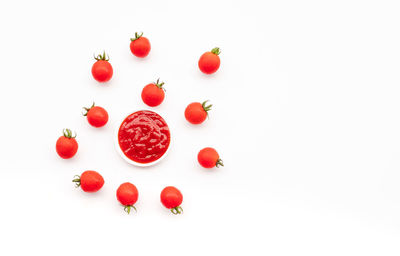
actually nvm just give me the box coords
[118,110,171,164]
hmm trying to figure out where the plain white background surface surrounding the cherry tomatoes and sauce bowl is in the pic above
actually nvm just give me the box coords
[0,0,400,255]
